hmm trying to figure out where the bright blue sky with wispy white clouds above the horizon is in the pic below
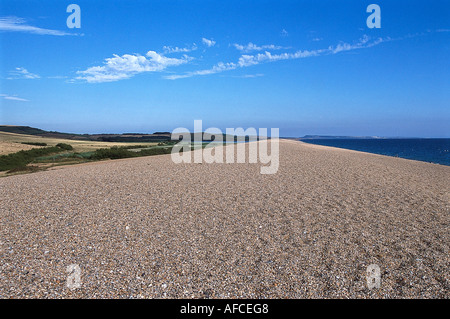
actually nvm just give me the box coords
[0,0,450,137]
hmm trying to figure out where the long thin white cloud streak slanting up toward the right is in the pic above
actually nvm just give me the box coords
[164,35,391,80]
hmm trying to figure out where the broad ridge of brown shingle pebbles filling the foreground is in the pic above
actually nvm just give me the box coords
[0,141,450,298]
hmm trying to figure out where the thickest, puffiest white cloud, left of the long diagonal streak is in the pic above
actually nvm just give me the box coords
[75,51,192,83]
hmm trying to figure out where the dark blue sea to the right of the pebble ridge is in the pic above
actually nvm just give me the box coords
[302,138,450,166]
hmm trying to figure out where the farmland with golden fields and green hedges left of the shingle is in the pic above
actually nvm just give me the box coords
[0,125,232,175]
